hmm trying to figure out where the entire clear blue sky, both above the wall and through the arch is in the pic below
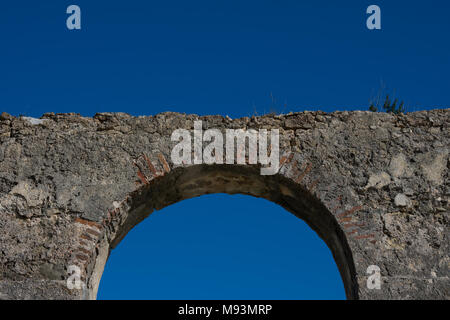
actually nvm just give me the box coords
[0,0,450,298]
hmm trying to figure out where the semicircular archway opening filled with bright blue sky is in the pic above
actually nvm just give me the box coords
[98,194,345,299]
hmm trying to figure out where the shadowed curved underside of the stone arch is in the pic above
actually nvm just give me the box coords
[91,165,358,300]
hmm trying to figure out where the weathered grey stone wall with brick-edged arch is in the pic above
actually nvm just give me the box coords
[0,109,450,299]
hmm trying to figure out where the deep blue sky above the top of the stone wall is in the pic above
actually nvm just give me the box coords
[0,0,450,117]
